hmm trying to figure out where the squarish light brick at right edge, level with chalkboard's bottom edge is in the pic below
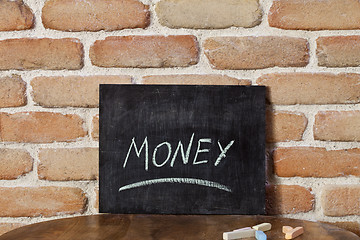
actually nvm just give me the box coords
[321,185,360,217]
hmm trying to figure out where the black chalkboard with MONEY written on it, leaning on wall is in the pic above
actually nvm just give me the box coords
[99,85,265,214]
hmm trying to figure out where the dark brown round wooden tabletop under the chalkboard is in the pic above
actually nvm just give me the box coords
[0,214,360,240]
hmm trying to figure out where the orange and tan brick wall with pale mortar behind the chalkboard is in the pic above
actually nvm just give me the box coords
[0,0,360,234]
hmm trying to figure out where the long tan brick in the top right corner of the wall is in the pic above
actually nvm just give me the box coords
[269,0,360,30]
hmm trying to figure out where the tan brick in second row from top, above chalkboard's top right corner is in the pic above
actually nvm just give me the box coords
[204,36,309,70]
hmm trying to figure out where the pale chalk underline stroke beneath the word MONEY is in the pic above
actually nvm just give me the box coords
[119,178,232,192]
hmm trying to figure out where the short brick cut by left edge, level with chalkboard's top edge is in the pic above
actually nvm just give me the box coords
[0,75,27,108]
